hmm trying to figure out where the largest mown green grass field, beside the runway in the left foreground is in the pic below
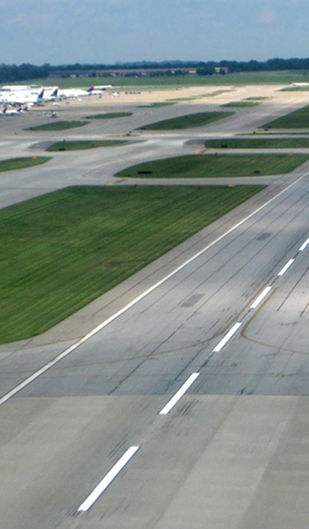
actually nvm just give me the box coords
[0,186,263,343]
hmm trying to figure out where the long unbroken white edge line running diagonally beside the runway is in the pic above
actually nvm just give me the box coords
[0,172,309,406]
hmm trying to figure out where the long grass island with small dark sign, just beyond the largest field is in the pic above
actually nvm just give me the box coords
[115,154,309,178]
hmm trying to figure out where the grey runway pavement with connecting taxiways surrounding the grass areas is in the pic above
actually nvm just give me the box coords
[0,87,309,529]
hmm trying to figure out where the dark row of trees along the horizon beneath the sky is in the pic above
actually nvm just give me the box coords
[0,58,309,83]
